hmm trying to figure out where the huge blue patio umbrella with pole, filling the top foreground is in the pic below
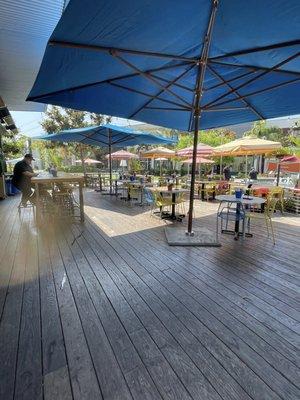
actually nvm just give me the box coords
[28,0,300,234]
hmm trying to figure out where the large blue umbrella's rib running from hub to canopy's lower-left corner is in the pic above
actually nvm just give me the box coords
[26,62,189,101]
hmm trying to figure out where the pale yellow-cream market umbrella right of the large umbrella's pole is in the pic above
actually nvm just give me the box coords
[213,136,282,177]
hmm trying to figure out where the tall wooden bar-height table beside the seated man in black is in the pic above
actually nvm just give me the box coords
[31,173,84,223]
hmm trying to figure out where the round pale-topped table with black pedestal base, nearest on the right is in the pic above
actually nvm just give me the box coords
[216,194,266,240]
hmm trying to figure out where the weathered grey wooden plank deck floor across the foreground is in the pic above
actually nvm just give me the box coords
[0,192,300,400]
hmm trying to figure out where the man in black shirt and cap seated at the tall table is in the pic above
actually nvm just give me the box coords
[12,154,38,206]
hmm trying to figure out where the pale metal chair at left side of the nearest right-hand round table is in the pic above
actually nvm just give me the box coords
[216,201,246,238]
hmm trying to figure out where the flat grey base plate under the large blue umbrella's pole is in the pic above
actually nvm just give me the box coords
[165,227,221,247]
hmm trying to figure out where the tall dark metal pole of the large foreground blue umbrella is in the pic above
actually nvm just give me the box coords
[186,0,219,236]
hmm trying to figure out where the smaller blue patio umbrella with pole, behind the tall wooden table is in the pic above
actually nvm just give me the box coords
[33,124,176,193]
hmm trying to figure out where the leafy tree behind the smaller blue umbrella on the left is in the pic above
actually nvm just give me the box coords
[41,106,110,173]
